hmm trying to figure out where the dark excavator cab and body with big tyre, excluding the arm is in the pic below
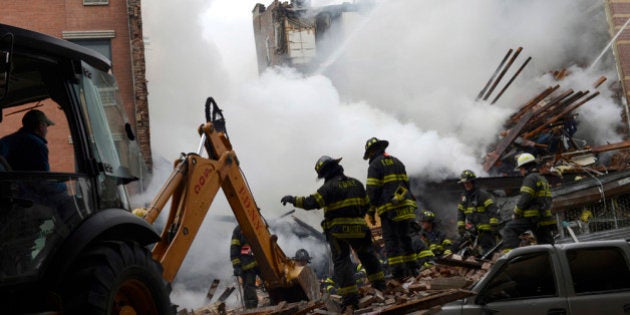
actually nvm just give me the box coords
[0,24,165,314]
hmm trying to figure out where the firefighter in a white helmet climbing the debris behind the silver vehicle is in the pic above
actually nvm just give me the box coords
[503,153,556,252]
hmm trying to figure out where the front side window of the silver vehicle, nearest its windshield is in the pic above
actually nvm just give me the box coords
[480,252,557,304]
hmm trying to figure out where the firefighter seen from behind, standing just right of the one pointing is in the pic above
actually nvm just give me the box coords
[363,137,418,279]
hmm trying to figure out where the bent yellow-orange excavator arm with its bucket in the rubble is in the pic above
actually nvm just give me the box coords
[144,100,320,303]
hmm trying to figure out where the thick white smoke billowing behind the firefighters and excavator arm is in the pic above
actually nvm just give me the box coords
[143,0,620,308]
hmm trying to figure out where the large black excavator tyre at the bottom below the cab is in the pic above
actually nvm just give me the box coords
[64,241,173,315]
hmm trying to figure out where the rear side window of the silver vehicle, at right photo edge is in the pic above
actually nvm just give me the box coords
[567,247,630,294]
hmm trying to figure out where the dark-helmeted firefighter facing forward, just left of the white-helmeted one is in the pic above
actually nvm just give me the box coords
[457,170,499,254]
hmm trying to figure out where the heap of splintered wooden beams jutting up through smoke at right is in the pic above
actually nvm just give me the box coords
[477,47,630,175]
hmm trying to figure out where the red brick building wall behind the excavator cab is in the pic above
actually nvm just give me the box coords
[0,0,151,169]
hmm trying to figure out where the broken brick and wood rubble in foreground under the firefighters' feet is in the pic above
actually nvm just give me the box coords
[177,255,500,315]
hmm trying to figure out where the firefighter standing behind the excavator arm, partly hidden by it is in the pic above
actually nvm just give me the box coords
[230,225,258,308]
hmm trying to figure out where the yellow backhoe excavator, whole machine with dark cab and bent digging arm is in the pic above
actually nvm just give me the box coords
[0,24,319,315]
